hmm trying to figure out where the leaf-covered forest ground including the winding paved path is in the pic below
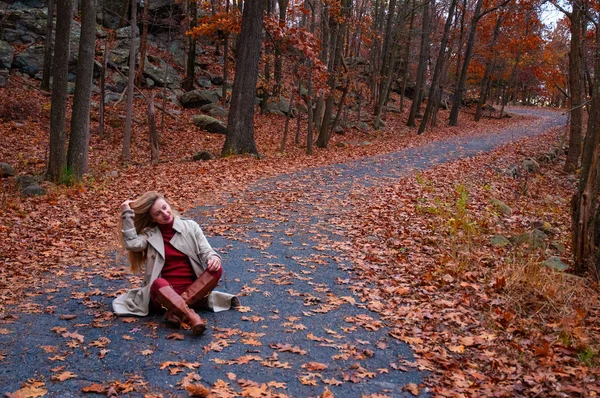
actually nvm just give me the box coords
[0,80,600,397]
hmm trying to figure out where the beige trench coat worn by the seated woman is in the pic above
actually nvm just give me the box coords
[112,210,234,316]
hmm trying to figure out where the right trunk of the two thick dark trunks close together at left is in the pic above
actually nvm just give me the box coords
[67,0,96,181]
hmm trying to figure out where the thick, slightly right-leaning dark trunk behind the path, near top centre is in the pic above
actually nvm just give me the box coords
[221,0,265,156]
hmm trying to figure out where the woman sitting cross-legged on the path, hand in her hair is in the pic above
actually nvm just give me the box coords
[113,192,237,336]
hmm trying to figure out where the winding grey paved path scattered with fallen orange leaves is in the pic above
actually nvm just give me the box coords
[0,109,566,397]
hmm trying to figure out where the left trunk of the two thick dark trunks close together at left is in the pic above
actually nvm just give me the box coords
[47,0,73,182]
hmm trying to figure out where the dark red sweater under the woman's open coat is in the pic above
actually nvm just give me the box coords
[158,222,196,293]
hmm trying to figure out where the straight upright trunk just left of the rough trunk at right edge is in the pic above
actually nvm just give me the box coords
[564,0,583,173]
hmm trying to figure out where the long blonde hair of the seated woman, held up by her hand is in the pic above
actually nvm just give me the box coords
[117,191,179,272]
